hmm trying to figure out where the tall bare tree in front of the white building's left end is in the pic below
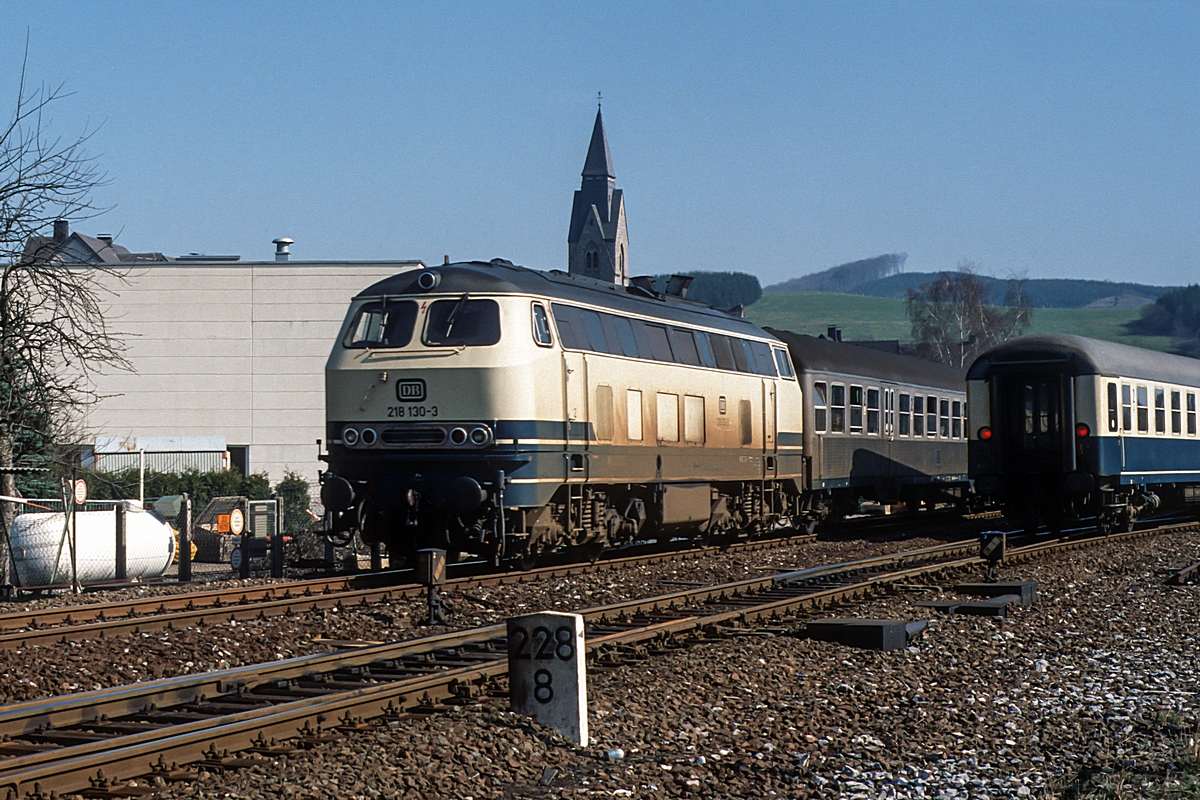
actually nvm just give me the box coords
[0,44,130,584]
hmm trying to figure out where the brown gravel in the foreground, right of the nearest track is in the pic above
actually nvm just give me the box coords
[129,527,1200,800]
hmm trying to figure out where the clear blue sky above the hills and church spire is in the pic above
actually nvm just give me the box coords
[0,0,1200,284]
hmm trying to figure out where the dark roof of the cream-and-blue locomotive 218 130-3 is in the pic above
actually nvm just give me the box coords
[355,259,772,338]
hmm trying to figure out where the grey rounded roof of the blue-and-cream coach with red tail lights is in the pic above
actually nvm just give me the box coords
[967,333,1200,386]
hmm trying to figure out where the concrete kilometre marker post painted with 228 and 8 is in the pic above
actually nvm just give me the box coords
[508,612,588,747]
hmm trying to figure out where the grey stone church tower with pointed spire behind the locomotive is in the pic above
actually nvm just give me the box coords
[566,109,629,284]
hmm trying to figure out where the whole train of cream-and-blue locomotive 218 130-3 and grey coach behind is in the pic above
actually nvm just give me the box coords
[322,259,966,564]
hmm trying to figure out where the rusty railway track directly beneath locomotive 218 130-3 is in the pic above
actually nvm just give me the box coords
[0,506,988,650]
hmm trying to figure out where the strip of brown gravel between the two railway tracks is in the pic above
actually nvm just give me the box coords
[0,539,937,703]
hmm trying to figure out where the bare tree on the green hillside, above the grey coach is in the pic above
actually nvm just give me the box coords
[905,260,1032,367]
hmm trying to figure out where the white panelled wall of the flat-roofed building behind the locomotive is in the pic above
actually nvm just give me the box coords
[84,261,422,483]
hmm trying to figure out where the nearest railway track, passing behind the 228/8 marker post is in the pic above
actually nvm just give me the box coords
[0,523,1171,798]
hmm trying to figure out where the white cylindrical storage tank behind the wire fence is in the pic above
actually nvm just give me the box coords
[12,511,175,587]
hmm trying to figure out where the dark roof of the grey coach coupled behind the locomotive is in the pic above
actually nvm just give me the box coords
[767,327,966,391]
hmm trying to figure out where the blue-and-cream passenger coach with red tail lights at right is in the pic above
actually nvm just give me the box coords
[967,335,1200,529]
